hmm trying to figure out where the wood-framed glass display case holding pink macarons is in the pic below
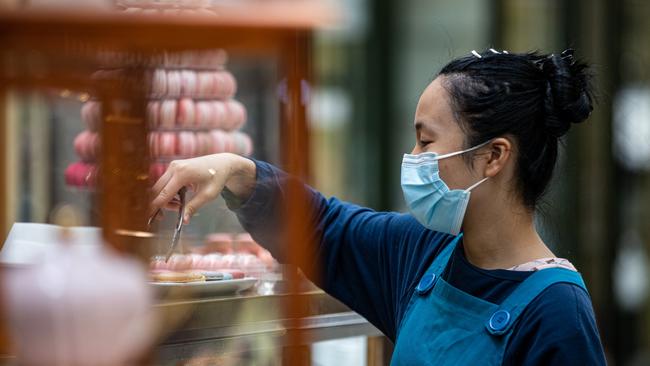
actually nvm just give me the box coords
[0,0,380,365]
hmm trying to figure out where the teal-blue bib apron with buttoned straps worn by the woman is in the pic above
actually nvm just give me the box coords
[391,234,587,365]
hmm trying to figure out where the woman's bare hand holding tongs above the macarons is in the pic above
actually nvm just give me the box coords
[150,153,256,224]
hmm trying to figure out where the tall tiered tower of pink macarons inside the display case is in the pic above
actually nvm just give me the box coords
[66,50,253,186]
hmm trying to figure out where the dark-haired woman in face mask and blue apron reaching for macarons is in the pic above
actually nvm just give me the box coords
[152,50,605,365]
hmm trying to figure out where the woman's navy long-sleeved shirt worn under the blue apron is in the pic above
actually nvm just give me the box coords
[224,161,606,365]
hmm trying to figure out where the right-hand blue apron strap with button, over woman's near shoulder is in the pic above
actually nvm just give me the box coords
[485,268,589,336]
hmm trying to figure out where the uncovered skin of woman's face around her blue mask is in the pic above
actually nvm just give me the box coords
[412,77,483,189]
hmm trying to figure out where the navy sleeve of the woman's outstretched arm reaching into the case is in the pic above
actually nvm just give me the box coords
[225,161,451,340]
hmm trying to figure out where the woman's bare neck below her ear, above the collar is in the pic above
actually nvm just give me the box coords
[463,200,554,269]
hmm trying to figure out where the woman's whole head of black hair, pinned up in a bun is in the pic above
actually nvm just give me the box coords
[439,49,593,208]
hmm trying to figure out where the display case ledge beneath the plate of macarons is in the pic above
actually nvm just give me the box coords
[157,290,382,365]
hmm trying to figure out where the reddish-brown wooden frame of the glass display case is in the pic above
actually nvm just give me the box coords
[0,1,350,364]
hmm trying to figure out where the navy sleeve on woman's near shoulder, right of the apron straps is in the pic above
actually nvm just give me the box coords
[504,283,606,366]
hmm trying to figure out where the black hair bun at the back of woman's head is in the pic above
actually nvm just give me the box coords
[540,49,593,137]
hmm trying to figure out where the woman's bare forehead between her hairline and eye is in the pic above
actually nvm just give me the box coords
[414,77,460,132]
